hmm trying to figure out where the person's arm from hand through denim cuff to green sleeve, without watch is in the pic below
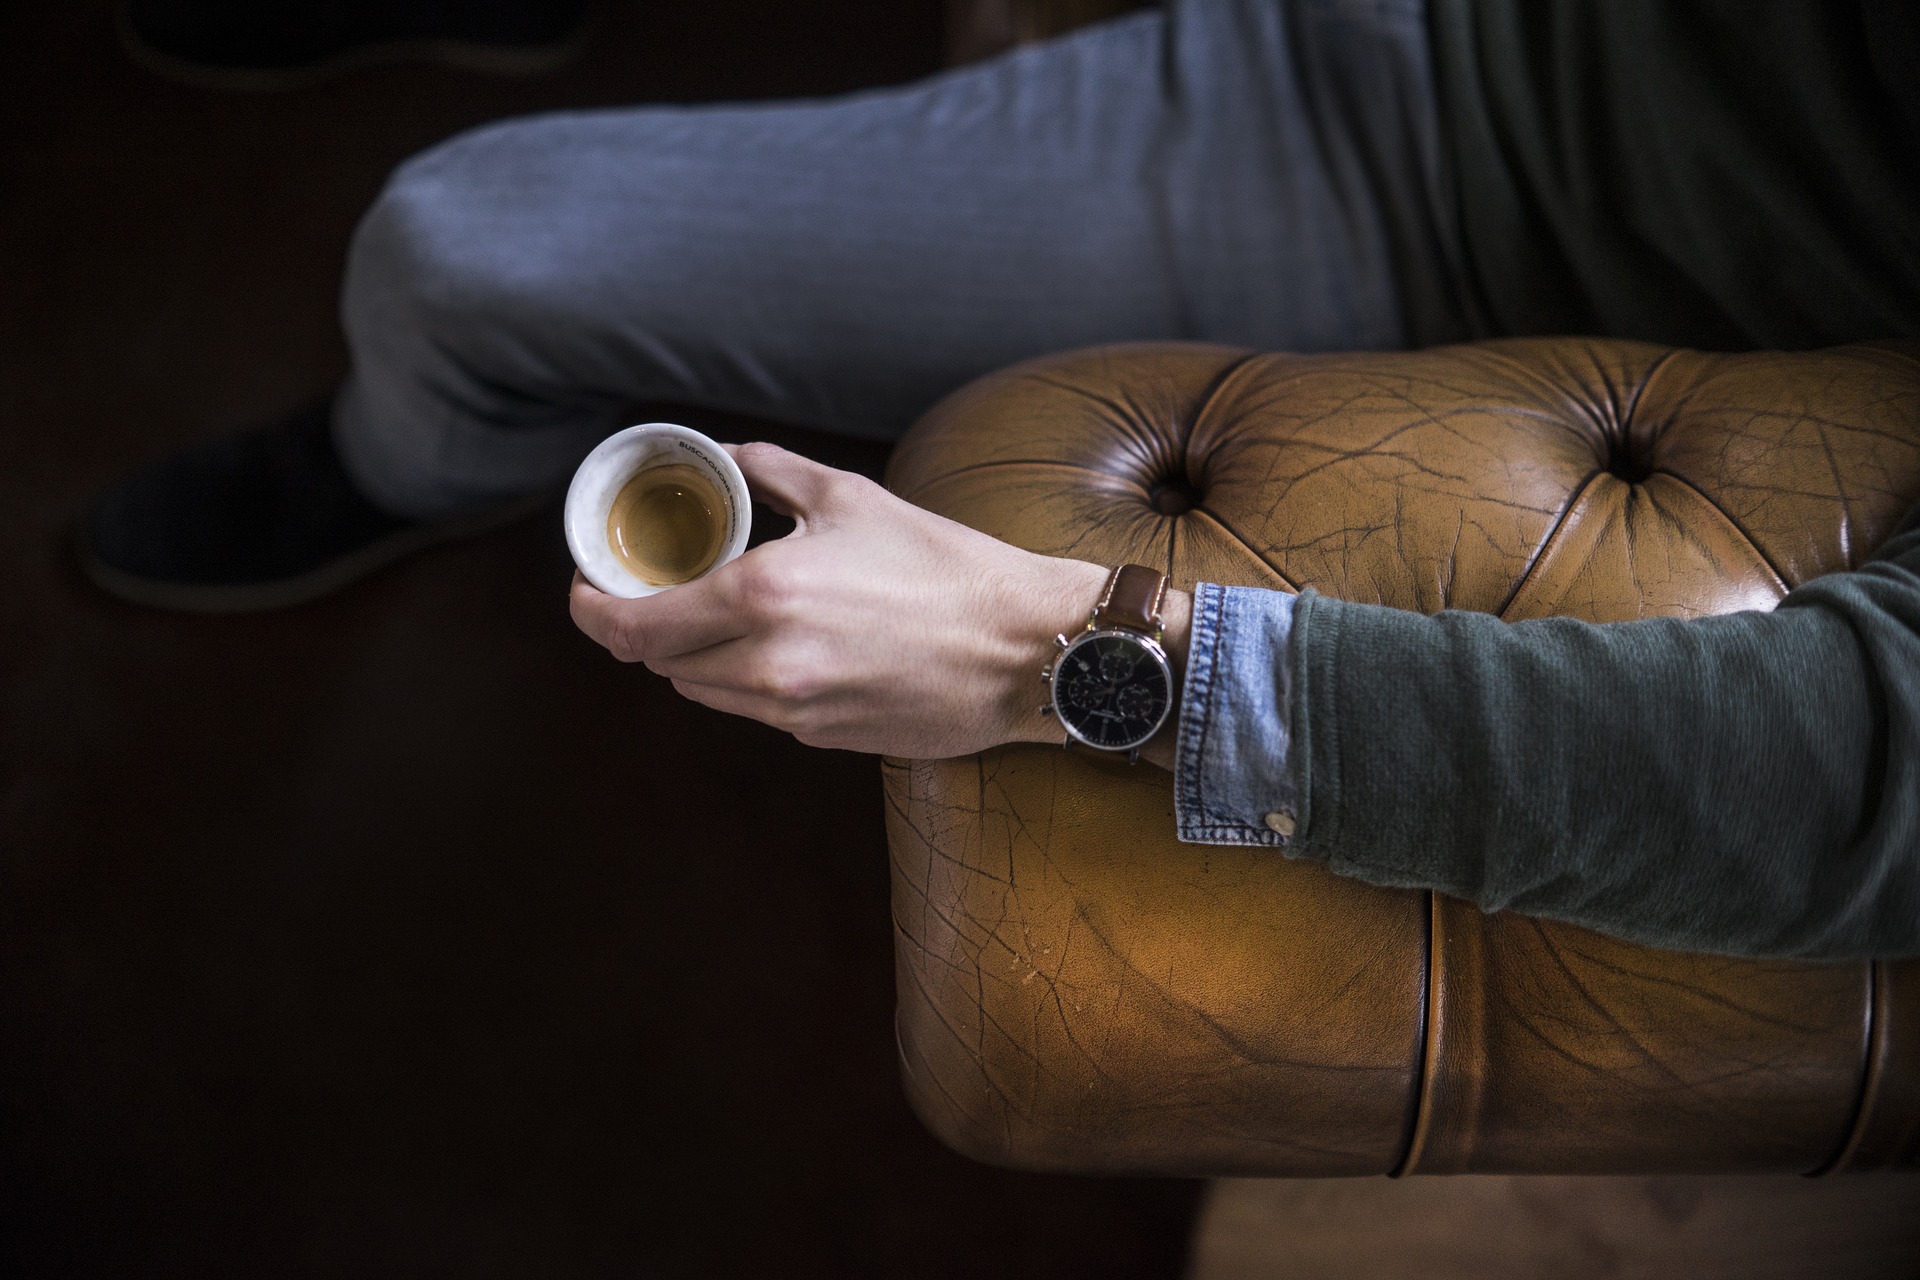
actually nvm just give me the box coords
[572,445,1920,956]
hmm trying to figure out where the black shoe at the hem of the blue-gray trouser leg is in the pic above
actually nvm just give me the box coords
[81,405,538,614]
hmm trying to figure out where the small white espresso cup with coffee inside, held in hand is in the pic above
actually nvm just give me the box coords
[566,422,753,601]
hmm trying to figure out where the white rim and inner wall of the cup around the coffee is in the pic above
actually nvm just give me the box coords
[564,422,753,601]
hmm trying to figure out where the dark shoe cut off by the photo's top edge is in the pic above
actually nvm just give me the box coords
[119,0,595,88]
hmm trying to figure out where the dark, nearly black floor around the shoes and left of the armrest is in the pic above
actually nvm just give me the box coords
[0,0,1196,1280]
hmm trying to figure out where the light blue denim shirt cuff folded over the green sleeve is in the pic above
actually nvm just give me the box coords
[1173,581,1296,848]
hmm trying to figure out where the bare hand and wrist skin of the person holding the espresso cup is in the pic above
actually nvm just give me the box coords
[572,445,1190,764]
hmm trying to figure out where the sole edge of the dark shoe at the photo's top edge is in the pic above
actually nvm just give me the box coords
[113,4,599,94]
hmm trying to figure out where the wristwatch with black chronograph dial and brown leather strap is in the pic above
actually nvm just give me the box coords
[1041,564,1173,760]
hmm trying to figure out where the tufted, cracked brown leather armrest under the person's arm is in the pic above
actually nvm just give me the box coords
[885,340,1920,1176]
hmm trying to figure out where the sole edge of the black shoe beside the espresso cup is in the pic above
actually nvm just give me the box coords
[79,491,551,614]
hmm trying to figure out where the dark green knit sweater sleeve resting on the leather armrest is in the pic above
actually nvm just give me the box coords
[1288,495,1920,958]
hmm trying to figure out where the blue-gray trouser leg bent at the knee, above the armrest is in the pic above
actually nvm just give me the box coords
[334,0,1461,516]
